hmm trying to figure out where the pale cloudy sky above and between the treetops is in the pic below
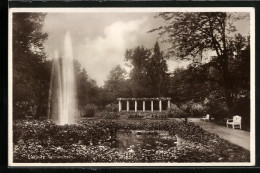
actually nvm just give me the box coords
[44,12,249,86]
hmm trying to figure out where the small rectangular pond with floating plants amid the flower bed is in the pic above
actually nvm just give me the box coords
[116,130,177,152]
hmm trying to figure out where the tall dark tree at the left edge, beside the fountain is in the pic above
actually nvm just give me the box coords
[12,13,51,118]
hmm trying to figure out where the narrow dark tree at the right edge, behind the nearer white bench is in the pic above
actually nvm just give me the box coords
[230,34,250,130]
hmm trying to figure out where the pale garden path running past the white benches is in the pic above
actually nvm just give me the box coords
[189,118,250,150]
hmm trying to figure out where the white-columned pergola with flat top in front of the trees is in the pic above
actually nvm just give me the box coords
[117,97,171,112]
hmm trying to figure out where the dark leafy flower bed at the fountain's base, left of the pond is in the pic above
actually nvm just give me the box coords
[13,120,116,146]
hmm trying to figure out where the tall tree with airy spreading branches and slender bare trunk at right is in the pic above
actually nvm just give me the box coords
[151,12,247,108]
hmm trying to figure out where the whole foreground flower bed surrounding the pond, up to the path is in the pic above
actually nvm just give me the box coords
[13,120,250,163]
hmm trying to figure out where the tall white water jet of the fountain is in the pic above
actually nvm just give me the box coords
[48,32,77,125]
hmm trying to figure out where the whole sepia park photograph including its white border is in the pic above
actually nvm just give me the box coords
[8,7,255,166]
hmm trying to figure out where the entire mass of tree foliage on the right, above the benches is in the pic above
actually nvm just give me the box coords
[151,12,250,121]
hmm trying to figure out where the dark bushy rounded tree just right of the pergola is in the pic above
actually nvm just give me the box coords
[168,60,223,105]
